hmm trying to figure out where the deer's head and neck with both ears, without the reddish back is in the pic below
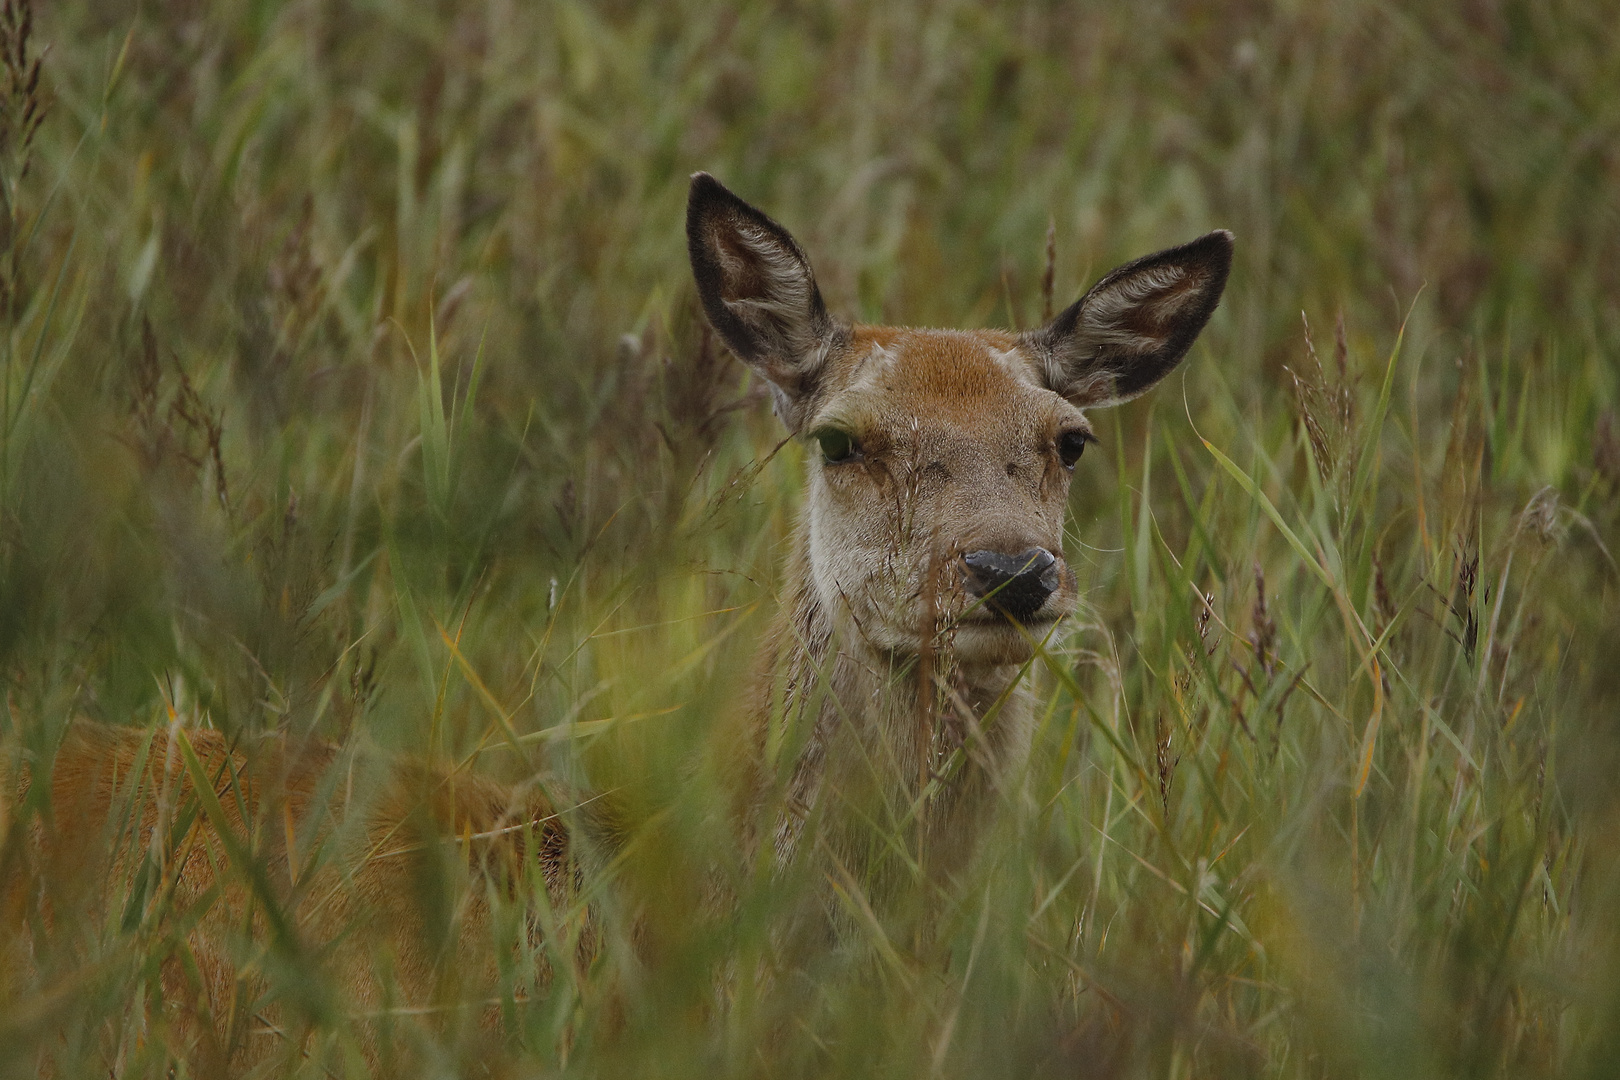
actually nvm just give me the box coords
[687,173,1233,879]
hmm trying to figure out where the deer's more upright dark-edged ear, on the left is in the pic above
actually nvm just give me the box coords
[687,173,834,431]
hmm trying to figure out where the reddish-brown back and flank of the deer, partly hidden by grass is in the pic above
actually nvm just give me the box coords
[0,722,572,1072]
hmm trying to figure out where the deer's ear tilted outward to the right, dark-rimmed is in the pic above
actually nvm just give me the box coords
[1024,228,1231,408]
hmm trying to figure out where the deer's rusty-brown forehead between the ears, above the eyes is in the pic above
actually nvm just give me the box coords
[810,325,1089,444]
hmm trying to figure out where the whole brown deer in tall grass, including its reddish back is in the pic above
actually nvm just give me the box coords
[0,173,1233,1074]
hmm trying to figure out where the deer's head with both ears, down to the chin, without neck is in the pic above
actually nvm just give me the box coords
[687,173,1231,665]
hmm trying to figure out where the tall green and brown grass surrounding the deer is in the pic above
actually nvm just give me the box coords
[0,0,1620,1078]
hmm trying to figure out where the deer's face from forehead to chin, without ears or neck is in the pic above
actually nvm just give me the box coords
[804,327,1092,662]
